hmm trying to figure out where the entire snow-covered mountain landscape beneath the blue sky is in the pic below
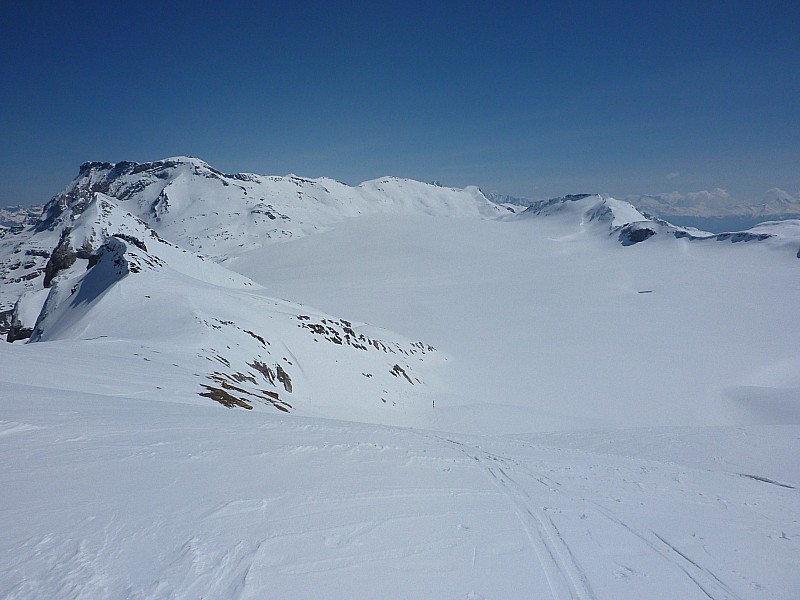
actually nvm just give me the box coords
[0,157,800,600]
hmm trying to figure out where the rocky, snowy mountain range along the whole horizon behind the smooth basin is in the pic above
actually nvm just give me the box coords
[0,157,798,346]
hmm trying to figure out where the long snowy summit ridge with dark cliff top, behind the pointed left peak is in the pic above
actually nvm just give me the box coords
[39,156,502,259]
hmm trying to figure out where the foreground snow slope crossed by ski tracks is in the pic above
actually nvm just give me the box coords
[0,372,800,598]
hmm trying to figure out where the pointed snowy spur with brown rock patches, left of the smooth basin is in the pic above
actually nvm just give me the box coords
[18,193,435,420]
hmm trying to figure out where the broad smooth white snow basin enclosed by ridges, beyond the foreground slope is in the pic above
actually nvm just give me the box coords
[236,210,800,433]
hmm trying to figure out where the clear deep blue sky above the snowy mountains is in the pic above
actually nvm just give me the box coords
[0,0,800,205]
